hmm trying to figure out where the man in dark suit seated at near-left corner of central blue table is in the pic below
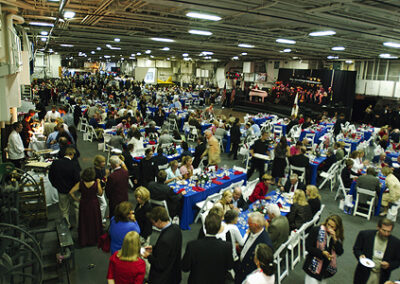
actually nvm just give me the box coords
[147,170,182,218]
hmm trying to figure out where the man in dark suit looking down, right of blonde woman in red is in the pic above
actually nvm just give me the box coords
[143,206,182,284]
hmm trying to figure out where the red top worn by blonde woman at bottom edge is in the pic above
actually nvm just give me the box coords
[107,251,146,284]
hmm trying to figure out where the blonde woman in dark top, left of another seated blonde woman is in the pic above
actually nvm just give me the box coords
[287,189,313,231]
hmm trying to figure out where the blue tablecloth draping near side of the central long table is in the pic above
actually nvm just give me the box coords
[173,170,247,230]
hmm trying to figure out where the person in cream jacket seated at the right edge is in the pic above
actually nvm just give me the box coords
[379,167,400,216]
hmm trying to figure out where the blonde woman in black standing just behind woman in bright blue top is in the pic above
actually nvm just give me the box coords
[135,186,152,244]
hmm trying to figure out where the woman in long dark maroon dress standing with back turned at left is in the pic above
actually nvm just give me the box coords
[69,168,103,247]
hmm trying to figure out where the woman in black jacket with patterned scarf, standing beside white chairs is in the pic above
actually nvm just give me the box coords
[303,215,344,284]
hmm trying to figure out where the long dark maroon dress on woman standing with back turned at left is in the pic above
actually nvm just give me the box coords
[78,181,103,246]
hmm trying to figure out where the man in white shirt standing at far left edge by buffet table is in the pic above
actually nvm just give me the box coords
[8,122,25,168]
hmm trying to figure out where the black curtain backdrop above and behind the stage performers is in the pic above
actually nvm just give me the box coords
[278,68,357,108]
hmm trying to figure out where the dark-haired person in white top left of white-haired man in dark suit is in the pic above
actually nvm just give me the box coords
[224,209,244,261]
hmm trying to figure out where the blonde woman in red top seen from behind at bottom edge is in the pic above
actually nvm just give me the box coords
[107,231,146,284]
